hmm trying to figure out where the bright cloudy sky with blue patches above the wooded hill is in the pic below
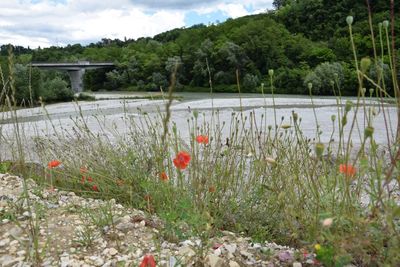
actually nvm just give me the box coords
[0,0,273,48]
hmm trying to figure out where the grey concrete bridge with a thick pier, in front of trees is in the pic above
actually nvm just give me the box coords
[31,61,114,93]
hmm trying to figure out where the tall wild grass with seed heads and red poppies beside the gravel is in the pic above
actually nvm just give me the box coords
[0,12,400,266]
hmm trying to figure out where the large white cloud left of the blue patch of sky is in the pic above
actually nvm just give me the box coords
[0,0,185,47]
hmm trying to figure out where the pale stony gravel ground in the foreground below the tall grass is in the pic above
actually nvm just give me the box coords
[0,174,318,267]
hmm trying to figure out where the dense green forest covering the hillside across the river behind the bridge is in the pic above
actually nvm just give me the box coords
[0,0,400,104]
